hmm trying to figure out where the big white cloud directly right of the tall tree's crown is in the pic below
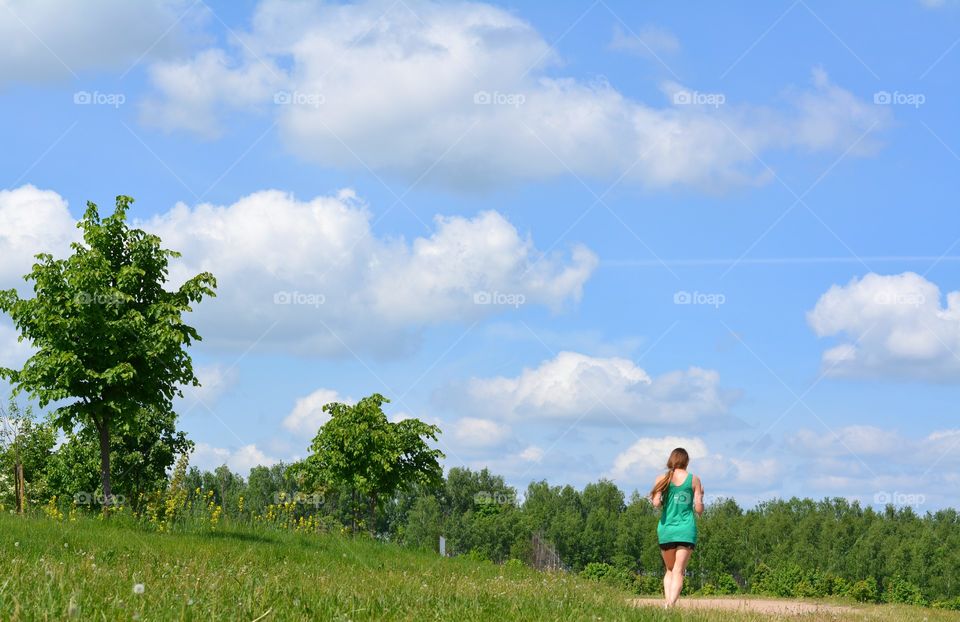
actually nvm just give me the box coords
[144,191,597,355]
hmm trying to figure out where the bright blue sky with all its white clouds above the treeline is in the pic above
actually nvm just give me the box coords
[0,0,960,510]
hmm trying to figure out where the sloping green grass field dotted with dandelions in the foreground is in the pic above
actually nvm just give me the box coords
[0,514,960,621]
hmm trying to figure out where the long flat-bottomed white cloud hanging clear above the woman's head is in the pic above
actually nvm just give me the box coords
[466,352,736,425]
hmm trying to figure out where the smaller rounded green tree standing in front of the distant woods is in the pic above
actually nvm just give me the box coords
[297,393,443,531]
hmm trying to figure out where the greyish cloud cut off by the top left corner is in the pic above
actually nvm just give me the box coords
[0,0,207,82]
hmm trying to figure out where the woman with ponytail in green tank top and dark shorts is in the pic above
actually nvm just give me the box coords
[650,447,703,607]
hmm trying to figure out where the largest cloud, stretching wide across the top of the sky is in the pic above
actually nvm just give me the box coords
[143,0,889,188]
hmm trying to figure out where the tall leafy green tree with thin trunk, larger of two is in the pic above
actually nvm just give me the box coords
[0,196,216,505]
